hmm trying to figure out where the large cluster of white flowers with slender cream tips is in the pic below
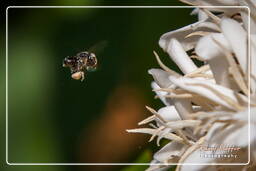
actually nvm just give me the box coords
[127,0,256,171]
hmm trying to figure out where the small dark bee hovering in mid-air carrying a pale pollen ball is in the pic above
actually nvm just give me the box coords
[63,51,98,81]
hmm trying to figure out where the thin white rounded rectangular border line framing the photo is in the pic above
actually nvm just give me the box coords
[5,6,251,166]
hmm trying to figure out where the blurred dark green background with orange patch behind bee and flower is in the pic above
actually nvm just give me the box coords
[0,0,195,171]
